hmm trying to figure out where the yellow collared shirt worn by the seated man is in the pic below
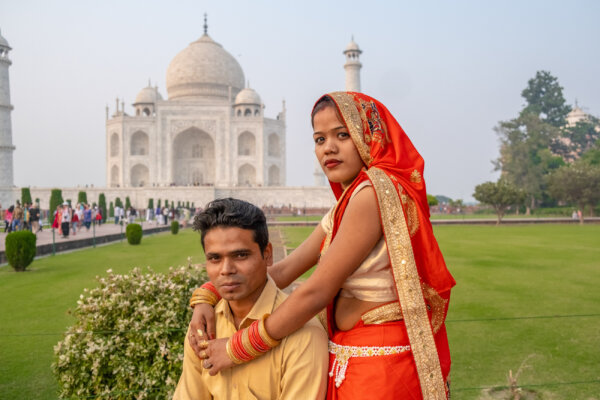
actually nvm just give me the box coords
[173,278,329,400]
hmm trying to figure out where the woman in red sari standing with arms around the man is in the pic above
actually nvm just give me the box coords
[197,92,455,399]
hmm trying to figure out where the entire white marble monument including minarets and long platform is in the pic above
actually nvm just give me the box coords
[0,19,362,208]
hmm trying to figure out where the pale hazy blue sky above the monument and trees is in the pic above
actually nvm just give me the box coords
[0,0,600,200]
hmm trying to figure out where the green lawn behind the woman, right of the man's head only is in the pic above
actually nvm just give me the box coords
[283,224,600,399]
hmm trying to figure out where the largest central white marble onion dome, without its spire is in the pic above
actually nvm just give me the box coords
[167,34,245,99]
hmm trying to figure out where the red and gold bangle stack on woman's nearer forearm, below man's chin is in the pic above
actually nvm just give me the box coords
[226,314,280,364]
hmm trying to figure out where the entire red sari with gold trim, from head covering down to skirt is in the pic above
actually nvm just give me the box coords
[322,92,455,399]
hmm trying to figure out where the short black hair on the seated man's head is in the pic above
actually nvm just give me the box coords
[194,197,269,254]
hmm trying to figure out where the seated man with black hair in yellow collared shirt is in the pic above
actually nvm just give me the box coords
[173,199,328,400]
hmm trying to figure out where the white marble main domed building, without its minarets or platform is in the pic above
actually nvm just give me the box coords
[106,21,285,187]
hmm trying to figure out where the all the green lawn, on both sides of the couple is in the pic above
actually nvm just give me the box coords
[0,224,600,400]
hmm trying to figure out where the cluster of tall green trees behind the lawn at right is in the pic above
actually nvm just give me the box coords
[473,71,600,223]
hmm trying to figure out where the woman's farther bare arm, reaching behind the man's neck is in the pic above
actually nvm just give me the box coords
[268,224,325,289]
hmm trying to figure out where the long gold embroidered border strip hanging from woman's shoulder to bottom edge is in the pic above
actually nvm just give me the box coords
[367,168,446,400]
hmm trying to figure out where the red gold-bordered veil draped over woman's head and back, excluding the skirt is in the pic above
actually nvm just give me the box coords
[317,92,455,399]
